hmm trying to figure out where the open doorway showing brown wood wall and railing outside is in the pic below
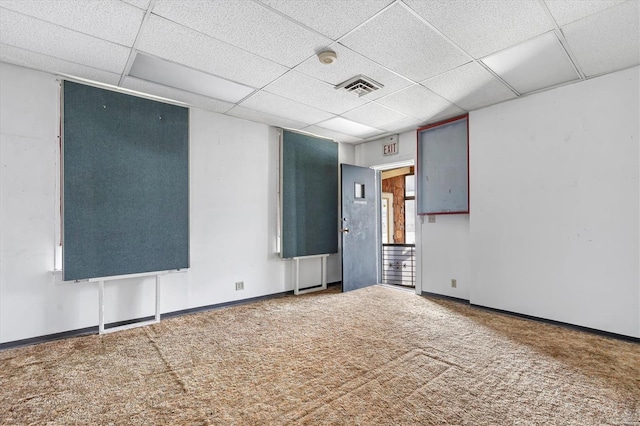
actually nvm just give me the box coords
[380,166,416,288]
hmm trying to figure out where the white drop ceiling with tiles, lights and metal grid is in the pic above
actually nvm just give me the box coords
[0,0,640,143]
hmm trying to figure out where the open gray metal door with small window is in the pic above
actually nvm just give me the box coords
[340,164,380,291]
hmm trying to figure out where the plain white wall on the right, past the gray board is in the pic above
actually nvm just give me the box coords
[469,67,640,337]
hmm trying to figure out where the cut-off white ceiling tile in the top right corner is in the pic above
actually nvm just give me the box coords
[562,0,640,76]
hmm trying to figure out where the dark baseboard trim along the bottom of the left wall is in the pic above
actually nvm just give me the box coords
[0,281,342,351]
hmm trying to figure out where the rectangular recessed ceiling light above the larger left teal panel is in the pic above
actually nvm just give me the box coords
[129,53,255,103]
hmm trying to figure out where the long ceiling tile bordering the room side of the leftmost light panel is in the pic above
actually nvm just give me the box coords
[137,15,287,87]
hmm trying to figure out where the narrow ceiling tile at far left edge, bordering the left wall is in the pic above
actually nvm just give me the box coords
[0,43,120,85]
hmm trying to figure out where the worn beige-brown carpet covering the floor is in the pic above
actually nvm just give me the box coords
[0,286,640,425]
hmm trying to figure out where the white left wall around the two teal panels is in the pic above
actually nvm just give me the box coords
[0,63,355,343]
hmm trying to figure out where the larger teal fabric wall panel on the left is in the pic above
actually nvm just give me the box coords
[63,81,189,280]
